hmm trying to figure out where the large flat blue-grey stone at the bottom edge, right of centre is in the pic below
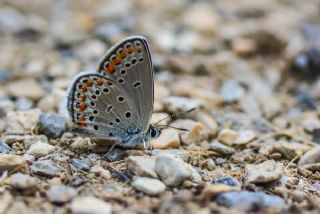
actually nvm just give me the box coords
[215,191,285,212]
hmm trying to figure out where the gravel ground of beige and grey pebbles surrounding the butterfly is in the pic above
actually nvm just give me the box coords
[0,0,320,214]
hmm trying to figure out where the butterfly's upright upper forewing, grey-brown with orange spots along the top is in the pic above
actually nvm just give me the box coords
[98,36,154,132]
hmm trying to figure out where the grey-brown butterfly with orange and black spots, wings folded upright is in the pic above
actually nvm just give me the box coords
[67,36,169,149]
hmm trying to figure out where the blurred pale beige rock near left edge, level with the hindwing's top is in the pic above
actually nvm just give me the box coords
[6,78,45,100]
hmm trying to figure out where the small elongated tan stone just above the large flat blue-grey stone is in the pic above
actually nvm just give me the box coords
[201,184,241,199]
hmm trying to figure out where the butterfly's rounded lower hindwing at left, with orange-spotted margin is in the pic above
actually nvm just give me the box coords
[68,72,137,140]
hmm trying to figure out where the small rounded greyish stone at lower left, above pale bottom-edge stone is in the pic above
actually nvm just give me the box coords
[47,185,77,204]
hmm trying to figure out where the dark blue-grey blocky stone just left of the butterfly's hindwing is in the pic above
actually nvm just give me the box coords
[39,113,66,138]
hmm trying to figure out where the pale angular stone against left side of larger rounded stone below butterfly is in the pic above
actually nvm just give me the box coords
[127,156,158,178]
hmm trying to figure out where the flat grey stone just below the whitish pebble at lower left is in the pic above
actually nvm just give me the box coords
[30,160,63,177]
